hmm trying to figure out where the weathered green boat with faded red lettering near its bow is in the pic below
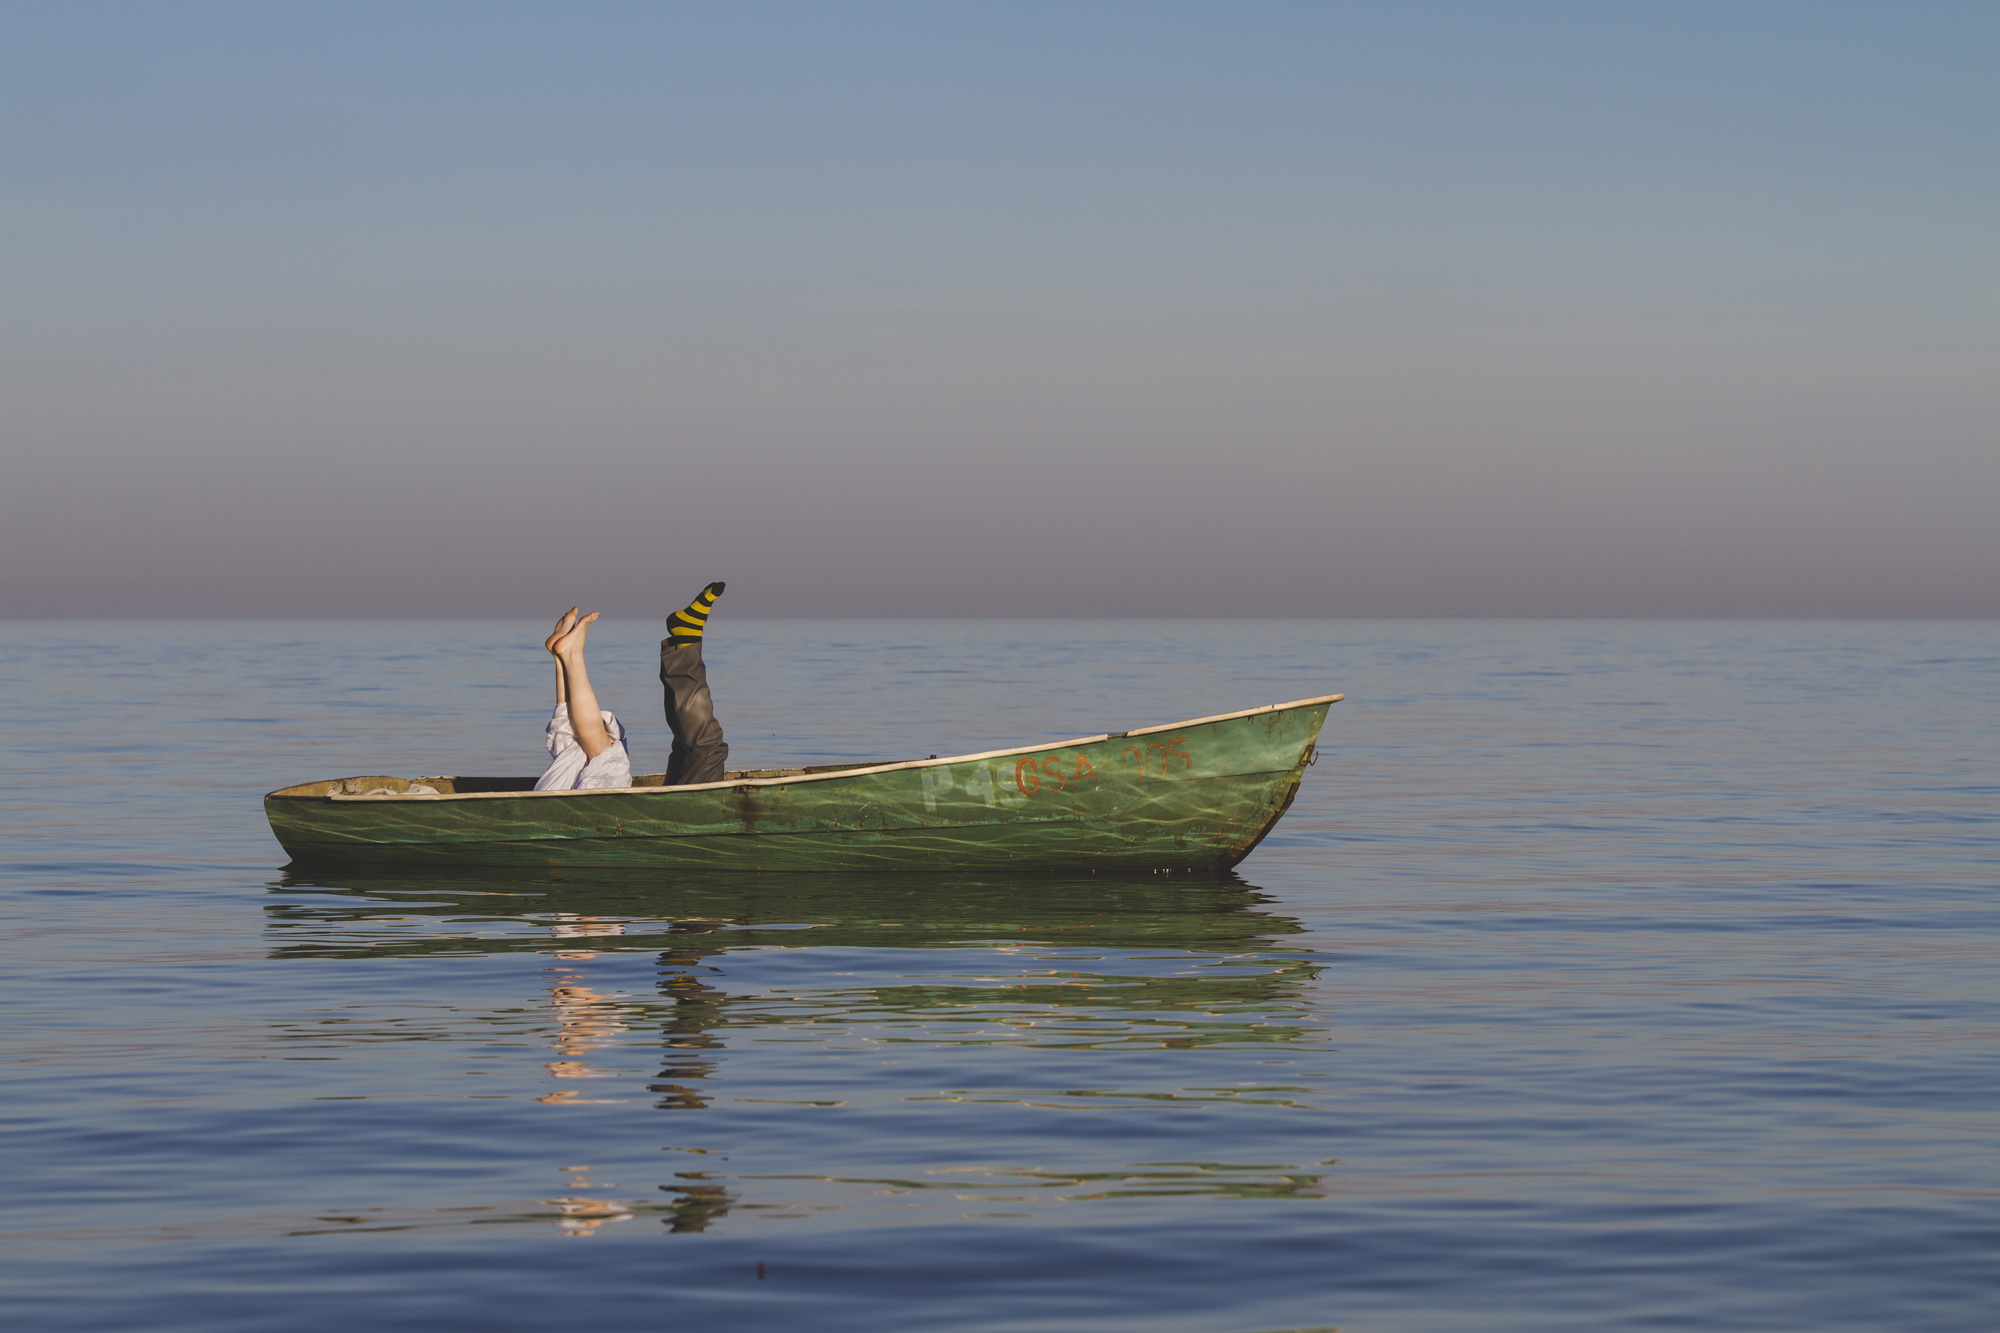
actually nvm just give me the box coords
[264,695,1340,871]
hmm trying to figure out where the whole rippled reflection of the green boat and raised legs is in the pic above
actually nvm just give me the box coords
[268,867,1326,1237]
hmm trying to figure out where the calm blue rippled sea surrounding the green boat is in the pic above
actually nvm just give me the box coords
[0,604,2000,1333]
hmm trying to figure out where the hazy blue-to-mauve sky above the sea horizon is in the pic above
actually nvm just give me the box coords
[0,0,2000,616]
